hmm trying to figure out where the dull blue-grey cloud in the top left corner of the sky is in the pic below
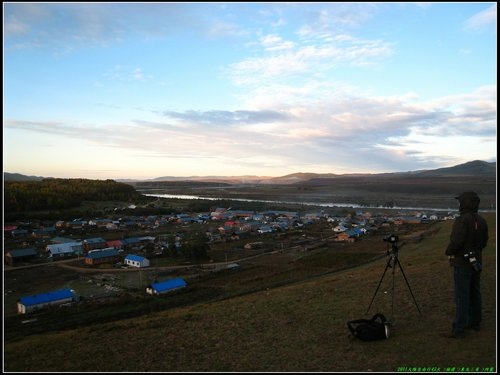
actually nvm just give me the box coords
[4,3,200,51]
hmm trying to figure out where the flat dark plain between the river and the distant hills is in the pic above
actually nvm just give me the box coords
[136,174,496,210]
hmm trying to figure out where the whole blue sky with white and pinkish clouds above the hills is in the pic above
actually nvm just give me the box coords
[3,2,497,179]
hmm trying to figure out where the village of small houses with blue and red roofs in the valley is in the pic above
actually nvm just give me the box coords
[4,205,453,314]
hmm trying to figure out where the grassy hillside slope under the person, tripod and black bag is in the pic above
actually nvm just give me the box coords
[4,214,497,372]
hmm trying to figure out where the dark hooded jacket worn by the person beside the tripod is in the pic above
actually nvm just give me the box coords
[446,192,488,267]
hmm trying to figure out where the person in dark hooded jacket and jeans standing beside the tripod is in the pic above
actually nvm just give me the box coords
[446,191,488,338]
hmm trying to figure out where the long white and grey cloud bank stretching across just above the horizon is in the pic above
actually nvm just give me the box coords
[4,82,496,174]
